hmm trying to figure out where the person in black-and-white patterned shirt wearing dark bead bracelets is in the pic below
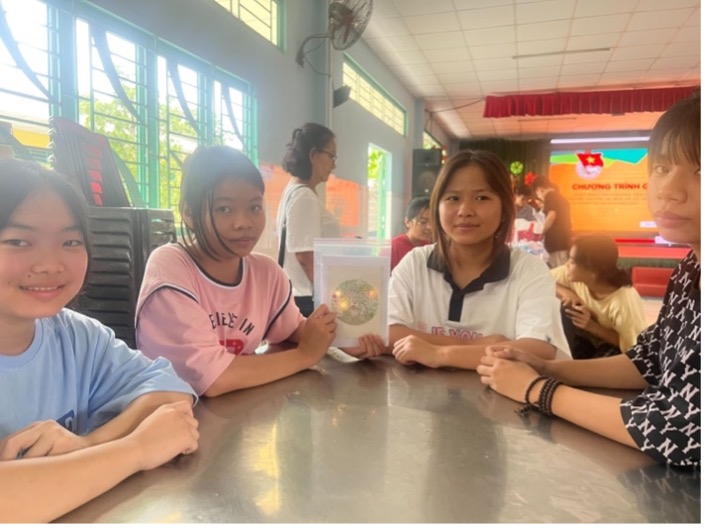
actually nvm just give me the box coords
[477,94,701,466]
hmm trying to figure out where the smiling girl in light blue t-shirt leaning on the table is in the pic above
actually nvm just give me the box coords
[0,160,198,522]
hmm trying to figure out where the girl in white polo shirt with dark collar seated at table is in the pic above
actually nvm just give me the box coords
[354,151,569,369]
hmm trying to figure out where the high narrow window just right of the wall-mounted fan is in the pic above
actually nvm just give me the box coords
[343,57,406,136]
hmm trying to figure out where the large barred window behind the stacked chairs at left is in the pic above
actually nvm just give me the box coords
[0,0,257,217]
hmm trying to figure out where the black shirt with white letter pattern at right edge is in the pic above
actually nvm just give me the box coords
[621,251,700,466]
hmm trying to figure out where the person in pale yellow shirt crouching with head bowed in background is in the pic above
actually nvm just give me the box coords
[551,235,646,359]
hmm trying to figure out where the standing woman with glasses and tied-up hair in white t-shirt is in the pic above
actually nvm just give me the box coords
[277,123,340,317]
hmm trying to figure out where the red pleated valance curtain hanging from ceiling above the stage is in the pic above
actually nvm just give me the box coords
[483,86,700,117]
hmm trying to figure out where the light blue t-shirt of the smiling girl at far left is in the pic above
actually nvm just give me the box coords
[0,309,196,438]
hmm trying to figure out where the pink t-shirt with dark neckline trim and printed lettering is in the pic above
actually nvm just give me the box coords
[136,244,305,395]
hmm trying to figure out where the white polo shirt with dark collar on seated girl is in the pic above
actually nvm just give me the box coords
[388,244,570,357]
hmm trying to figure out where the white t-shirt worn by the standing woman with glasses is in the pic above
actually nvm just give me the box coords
[277,180,340,297]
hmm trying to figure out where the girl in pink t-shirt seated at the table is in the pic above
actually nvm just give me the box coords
[136,146,383,396]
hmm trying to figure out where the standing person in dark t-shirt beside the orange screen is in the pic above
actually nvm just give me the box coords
[531,176,573,268]
